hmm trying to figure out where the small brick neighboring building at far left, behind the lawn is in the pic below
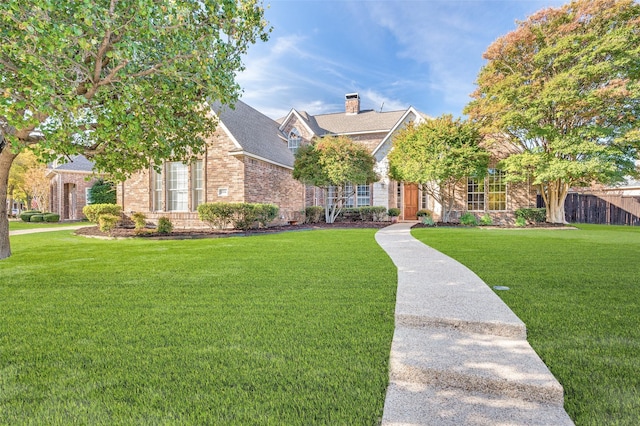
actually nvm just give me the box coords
[47,155,96,220]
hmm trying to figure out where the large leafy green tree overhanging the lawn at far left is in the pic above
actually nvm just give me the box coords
[0,0,269,259]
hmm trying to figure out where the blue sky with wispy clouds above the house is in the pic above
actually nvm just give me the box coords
[238,0,568,118]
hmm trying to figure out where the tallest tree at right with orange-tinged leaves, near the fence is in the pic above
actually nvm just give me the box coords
[465,0,640,223]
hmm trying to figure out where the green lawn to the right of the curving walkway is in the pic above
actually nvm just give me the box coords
[413,225,640,425]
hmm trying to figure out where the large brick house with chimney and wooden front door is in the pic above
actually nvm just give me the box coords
[118,93,536,228]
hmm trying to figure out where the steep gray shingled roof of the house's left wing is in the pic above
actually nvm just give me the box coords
[211,101,294,167]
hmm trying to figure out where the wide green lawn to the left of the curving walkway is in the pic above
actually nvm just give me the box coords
[0,229,396,425]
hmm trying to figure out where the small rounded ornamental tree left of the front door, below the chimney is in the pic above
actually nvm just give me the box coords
[293,136,378,223]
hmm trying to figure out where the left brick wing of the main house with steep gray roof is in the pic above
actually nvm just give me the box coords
[117,101,304,228]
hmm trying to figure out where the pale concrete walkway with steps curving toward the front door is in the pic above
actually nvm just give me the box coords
[376,223,573,426]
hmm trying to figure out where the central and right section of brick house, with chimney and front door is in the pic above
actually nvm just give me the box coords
[279,93,536,223]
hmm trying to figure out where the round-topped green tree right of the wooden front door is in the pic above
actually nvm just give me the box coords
[389,115,489,222]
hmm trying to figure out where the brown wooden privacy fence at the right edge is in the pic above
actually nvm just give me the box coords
[564,194,640,226]
